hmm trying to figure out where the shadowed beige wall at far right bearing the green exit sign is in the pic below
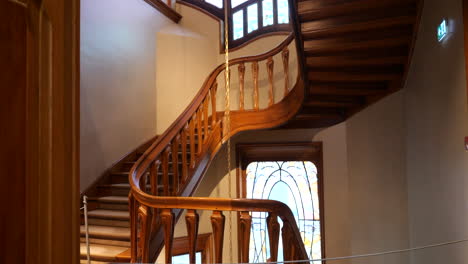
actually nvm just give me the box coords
[405,0,468,264]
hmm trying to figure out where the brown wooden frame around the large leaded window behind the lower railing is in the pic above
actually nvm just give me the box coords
[236,141,326,263]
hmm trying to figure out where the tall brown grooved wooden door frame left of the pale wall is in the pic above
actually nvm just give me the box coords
[24,0,80,264]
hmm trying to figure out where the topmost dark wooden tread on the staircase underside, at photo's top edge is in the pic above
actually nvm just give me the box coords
[298,0,417,21]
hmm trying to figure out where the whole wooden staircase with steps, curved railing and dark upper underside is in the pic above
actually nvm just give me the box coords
[81,0,422,263]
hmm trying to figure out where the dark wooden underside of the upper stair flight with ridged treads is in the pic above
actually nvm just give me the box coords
[287,0,422,128]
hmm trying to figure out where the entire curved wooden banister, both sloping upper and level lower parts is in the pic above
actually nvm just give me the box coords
[129,2,307,263]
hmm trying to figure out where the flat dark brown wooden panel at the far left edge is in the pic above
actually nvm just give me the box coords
[0,1,26,263]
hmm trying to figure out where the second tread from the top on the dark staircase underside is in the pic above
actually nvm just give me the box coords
[301,16,415,40]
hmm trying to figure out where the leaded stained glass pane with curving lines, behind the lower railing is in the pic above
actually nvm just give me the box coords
[246,161,322,263]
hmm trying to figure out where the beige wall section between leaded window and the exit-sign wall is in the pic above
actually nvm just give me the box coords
[346,92,409,264]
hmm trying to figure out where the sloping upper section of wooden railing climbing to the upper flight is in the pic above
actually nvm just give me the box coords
[129,35,304,260]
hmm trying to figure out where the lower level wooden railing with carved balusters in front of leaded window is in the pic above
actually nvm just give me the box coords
[131,197,308,263]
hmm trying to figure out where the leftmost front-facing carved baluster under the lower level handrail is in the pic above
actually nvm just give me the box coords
[137,205,152,263]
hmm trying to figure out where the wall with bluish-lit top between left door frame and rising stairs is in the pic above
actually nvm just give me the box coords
[80,0,172,191]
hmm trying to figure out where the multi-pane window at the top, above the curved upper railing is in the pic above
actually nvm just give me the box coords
[181,0,291,49]
